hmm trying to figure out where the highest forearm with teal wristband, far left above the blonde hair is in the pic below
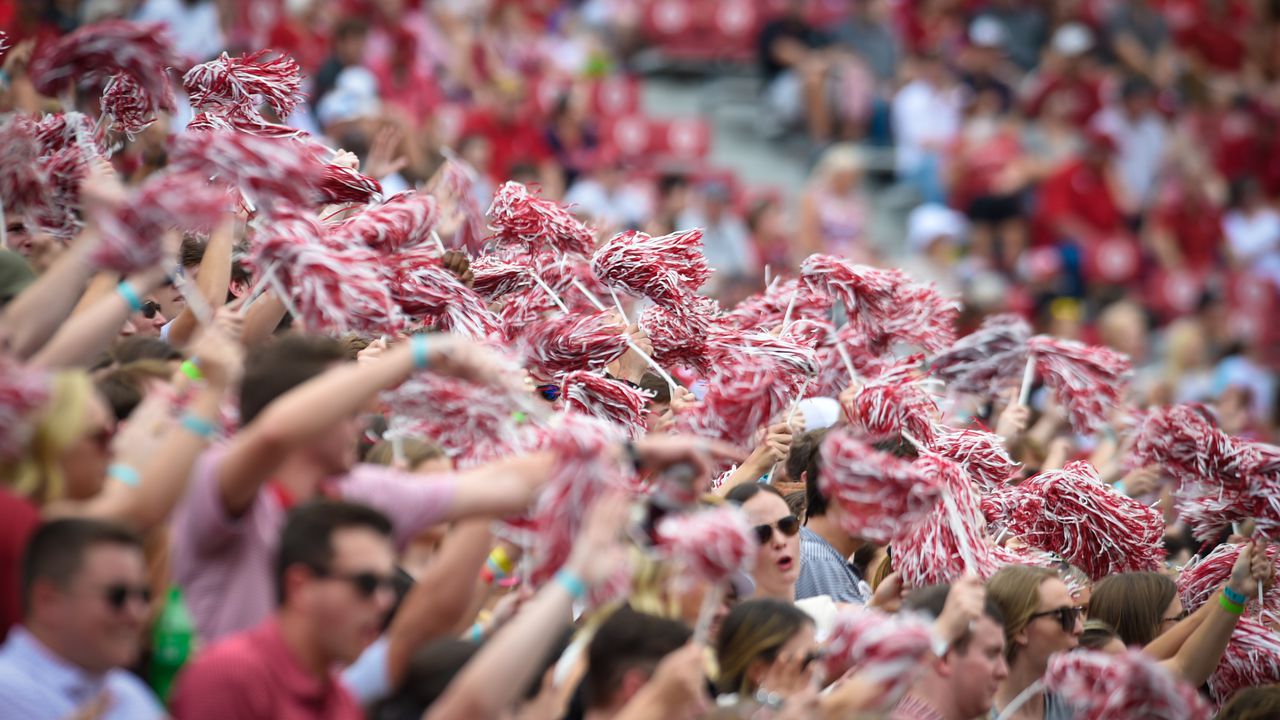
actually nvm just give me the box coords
[31,269,164,369]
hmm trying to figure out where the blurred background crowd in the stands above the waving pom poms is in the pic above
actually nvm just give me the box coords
[0,0,1280,439]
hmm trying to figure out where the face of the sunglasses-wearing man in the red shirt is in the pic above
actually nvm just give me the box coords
[307,528,396,664]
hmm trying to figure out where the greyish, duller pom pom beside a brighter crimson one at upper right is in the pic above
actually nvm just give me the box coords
[929,315,1032,397]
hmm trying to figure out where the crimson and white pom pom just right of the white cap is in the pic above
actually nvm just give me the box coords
[845,359,938,445]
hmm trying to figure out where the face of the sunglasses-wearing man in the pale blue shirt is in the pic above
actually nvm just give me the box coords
[40,544,148,673]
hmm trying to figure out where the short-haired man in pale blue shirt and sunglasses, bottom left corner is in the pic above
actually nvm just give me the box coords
[0,519,164,720]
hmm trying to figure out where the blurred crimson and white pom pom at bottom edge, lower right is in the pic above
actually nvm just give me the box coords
[1044,648,1212,720]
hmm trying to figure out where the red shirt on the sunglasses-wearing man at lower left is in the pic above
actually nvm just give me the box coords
[172,616,365,720]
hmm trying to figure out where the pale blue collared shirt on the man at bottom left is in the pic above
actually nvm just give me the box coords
[0,625,165,720]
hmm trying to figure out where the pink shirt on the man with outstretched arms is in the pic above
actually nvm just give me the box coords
[170,447,454,643]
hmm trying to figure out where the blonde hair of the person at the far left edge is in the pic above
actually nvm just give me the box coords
[0,372,93,506]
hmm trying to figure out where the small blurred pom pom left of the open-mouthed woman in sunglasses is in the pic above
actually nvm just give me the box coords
[657,505,759,584]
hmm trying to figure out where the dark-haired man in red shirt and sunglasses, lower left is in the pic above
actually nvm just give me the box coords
[173,500,396,720]
